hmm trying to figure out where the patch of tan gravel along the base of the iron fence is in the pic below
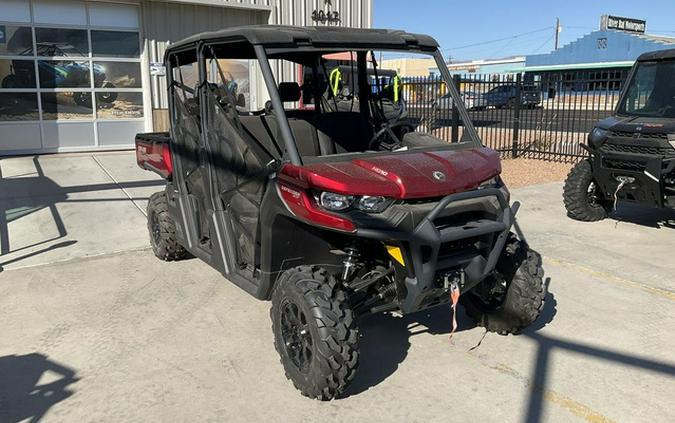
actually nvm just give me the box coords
[502,159,573,188]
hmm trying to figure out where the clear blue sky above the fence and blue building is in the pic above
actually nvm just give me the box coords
[373,0,675,60]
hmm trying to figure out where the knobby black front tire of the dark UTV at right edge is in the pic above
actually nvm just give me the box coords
[563,159,607,222]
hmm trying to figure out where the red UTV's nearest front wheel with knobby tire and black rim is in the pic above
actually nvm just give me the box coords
[270,266,359,401]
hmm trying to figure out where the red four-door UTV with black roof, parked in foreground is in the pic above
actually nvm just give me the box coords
[136,26,545,400]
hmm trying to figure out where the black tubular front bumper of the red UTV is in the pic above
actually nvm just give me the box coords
[357,188,519,313]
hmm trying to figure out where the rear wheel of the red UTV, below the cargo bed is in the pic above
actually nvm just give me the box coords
[147,192,190,261]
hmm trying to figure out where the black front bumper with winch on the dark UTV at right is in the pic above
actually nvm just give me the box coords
[591,148,675,207]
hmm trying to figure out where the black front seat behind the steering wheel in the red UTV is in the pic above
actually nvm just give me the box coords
[314,112,374,156]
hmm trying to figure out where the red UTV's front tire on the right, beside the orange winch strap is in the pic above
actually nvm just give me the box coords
[460,235,546,335]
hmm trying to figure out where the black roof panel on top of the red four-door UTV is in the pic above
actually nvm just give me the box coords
[169,25,438,50]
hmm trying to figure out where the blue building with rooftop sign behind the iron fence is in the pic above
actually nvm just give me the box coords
[512,16,675,91]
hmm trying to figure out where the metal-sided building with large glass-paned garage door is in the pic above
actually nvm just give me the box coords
[0,0,372,155]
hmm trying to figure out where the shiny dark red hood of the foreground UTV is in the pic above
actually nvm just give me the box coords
[279,148,501,199]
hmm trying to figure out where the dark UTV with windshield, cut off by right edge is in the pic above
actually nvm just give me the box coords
[563,49,675,222]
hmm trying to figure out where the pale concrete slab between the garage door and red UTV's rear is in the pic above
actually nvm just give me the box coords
[0,151,163,270]
